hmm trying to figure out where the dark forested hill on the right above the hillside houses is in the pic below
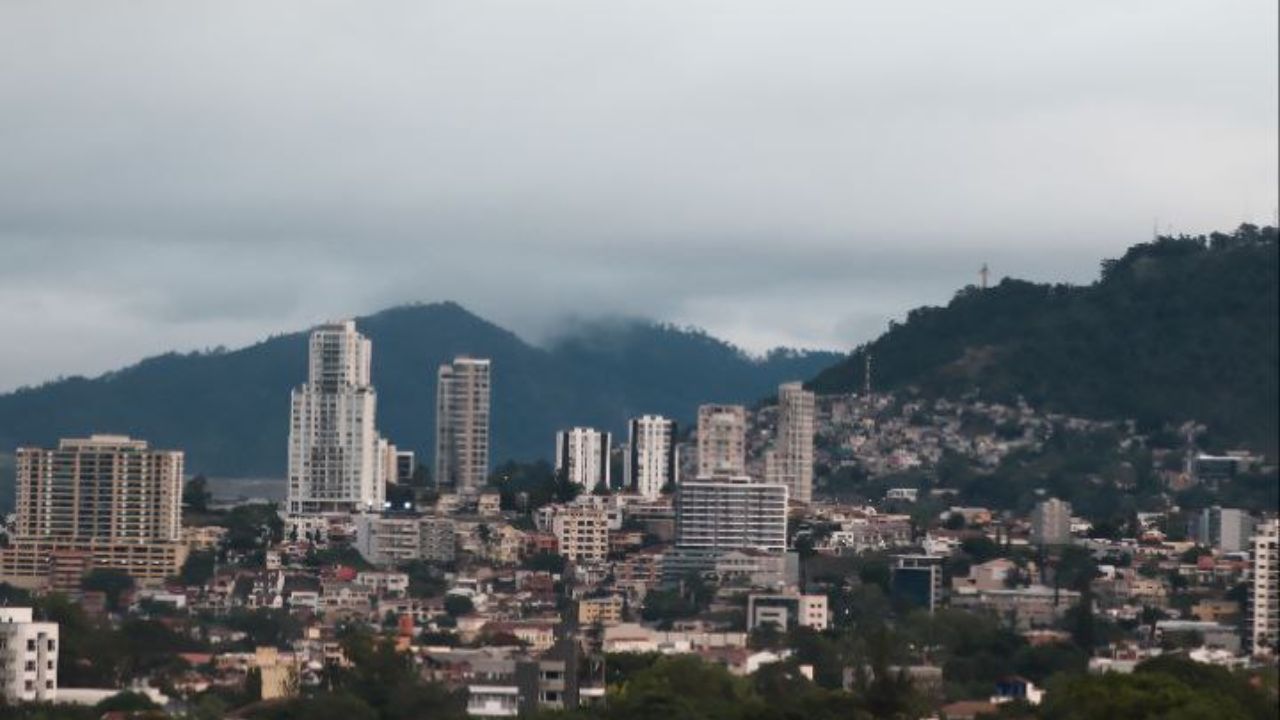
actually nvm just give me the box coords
[810,225,1280,457]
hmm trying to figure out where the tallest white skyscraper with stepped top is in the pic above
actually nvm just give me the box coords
[288,320,376,515]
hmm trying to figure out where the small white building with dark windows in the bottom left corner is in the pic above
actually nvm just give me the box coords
[0,607,58,702]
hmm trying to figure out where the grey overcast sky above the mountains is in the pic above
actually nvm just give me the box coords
[0,0,1277,389]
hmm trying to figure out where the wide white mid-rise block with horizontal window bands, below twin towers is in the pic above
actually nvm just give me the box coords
[675,475,787,552]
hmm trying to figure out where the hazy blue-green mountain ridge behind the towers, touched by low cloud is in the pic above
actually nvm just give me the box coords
[0,304,840,484]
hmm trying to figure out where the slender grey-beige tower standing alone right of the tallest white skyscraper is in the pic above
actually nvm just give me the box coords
[435,357,490,492]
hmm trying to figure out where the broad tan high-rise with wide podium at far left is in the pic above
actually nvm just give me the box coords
[0,436,187,588]
